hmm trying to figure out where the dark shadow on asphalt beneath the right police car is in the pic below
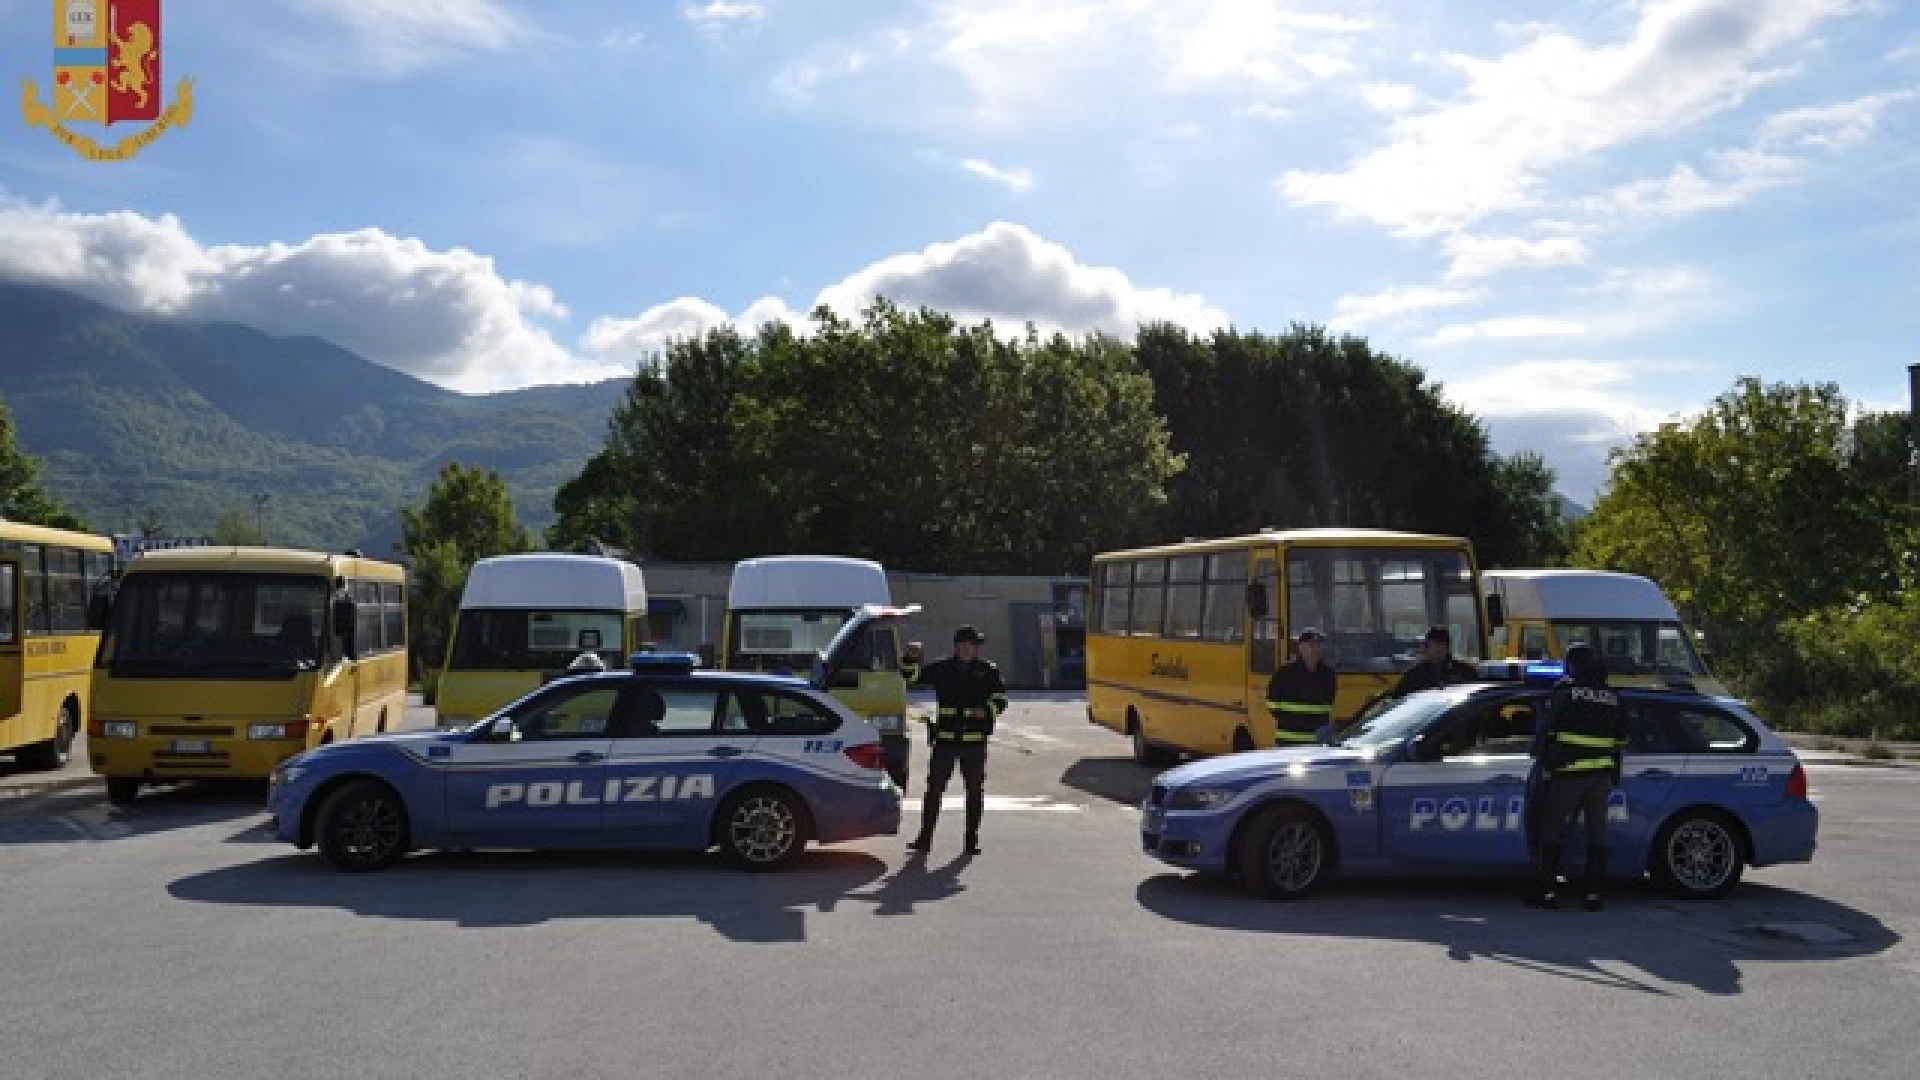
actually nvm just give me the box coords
[1135,872,1901,997]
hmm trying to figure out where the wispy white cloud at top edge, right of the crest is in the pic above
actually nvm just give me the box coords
[288,0,536,79]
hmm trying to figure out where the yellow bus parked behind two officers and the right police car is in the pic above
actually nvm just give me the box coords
[1087,528,1486,767]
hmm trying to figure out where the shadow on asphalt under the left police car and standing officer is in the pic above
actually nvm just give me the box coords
[167,849,968,944]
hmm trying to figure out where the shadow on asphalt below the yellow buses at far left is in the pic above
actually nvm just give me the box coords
[0,780,273,847]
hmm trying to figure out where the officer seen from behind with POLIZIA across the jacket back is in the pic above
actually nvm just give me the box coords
[1526,644,1626,911]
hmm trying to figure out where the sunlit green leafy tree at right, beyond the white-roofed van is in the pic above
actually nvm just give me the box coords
[1574,379,1903,663]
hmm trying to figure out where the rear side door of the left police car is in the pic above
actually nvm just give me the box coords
[605,678,758,849]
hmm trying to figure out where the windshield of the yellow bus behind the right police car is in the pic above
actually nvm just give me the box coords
[1286,548,1482,673]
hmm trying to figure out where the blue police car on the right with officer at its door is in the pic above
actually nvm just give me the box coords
[1140,663,1818,899]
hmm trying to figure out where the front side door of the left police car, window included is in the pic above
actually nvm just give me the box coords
[444,676,632,847]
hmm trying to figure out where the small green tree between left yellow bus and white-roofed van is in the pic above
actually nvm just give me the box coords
[399,461,534,675]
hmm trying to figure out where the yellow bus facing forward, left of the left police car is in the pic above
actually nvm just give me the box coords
[86,548,407,803]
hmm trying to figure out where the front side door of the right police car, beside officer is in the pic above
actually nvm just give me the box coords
[1379,700,1536,865]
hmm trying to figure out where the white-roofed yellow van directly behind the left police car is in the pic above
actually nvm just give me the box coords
[434,552,647,726]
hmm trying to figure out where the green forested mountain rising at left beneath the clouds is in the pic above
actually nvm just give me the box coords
[0,282,626,555]
